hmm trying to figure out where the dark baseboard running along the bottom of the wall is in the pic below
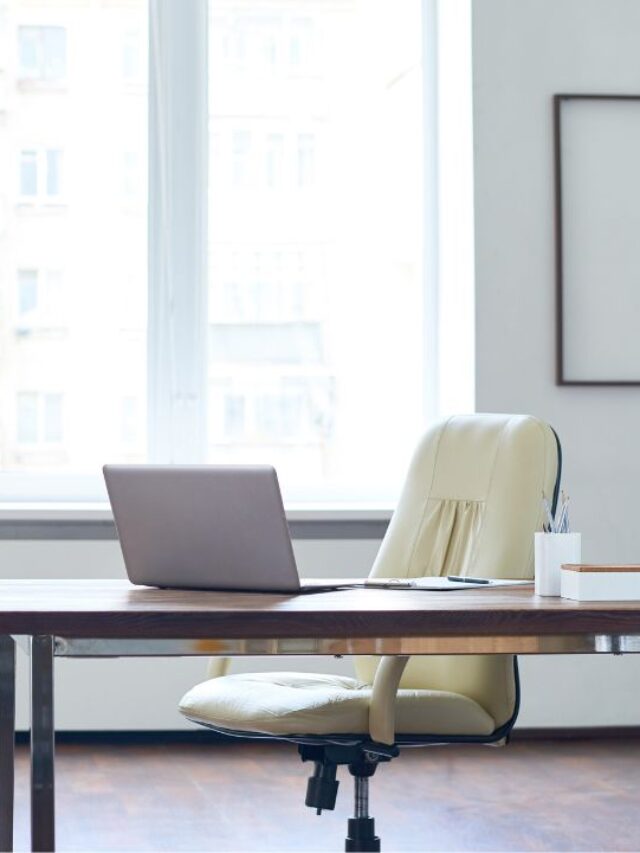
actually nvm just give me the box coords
[11,726,640,745]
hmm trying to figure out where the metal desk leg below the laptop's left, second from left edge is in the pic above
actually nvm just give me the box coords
[31,636,55,851]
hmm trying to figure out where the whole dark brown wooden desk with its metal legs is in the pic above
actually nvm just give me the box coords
[0,580,640,850]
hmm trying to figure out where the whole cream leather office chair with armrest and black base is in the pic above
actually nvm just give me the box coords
[180,414,561,851]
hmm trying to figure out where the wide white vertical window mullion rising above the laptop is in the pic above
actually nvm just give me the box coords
[147,0,208,463]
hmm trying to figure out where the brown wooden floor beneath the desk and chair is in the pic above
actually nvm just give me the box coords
[11,740,640,853]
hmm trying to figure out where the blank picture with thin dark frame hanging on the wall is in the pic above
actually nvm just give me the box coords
[553,94,640,386]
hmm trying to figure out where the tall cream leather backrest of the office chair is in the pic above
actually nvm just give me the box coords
[355,414,559,727]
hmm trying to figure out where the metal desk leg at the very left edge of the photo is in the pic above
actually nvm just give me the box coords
[0,634,16,851]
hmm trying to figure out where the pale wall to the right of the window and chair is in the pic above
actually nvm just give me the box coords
[473,0,640,726]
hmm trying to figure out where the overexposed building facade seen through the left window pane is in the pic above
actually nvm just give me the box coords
[0,0,148,480]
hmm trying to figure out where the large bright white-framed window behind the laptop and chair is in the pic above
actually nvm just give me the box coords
[0,0,468,505]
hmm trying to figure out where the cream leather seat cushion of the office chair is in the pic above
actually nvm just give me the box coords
[180,672,496,735]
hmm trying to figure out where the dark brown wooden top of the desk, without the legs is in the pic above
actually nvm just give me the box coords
[0,579,640,639]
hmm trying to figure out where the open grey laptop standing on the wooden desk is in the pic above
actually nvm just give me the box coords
[103,465,344,593]
